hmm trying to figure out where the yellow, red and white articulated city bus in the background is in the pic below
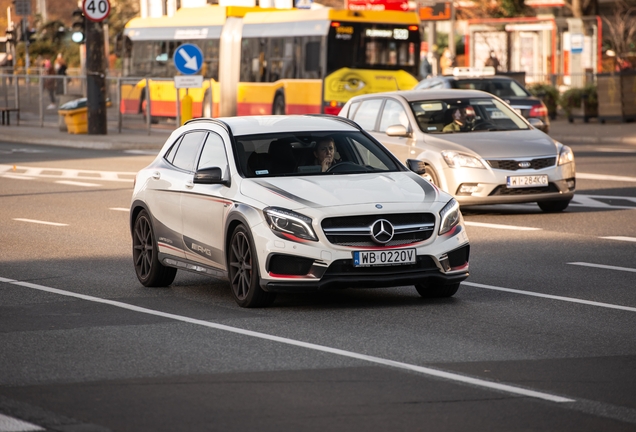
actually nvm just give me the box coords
[122,5,420,117]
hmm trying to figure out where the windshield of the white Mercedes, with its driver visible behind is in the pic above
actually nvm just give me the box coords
[236,131,402,178]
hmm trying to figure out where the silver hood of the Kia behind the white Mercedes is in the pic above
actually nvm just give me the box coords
[423,129,557,159]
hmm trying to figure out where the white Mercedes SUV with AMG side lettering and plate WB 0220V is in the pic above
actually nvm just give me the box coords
[130,115,470,307]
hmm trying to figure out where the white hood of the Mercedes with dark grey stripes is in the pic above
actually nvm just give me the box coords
[241,172,440,210]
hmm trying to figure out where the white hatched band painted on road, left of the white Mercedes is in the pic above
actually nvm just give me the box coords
[0,165,137,183]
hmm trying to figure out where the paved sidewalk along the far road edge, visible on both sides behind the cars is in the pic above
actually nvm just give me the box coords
[0,117,636,150]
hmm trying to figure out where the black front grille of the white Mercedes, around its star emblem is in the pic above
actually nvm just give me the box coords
[322,213,435,247]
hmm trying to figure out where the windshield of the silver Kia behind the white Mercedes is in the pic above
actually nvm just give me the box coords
[410,98,530,134]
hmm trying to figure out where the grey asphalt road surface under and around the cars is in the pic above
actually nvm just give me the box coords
[0,139,636,432]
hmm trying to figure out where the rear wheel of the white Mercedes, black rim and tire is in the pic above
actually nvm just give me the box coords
[132,210,177,287]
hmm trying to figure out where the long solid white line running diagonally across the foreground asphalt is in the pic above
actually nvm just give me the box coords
[0,277,575,403]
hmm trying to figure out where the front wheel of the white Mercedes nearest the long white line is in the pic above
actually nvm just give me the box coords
[228,225,276,308]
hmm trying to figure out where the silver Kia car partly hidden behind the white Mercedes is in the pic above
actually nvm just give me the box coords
[340,89,576,212]
